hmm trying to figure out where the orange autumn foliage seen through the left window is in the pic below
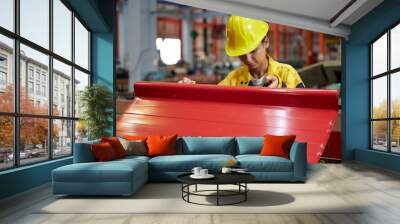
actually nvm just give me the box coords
[0,85,59,149]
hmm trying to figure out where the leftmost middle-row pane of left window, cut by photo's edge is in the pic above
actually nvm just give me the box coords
[0,35,14,112]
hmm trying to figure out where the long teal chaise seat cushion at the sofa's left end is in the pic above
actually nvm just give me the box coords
[52,159,147,182]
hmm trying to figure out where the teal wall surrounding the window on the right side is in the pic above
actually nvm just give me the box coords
[342,0,400,170]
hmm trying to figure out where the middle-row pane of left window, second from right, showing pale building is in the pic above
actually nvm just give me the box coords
[52,59,72,117]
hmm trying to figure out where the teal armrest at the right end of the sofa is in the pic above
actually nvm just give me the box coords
[290,142,307,181]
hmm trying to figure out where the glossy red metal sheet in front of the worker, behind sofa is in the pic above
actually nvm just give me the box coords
[117,82,338,163]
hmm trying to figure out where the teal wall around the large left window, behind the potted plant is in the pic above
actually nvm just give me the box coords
[0,0,115,199]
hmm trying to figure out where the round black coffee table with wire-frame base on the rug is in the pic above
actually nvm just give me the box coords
[177,173,255,206]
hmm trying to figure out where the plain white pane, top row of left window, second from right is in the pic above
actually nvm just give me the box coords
[53,0,72,60]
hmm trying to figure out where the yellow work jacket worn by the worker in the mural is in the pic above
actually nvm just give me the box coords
[218,57,304,88]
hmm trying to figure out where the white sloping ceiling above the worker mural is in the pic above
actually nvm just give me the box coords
[167,0,383,37]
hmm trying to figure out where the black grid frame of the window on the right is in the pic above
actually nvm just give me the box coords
[368,21,400,155]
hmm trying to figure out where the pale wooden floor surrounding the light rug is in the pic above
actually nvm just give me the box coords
[0,163,400,224]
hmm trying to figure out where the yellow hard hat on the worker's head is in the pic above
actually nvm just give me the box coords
[225,16,269,57]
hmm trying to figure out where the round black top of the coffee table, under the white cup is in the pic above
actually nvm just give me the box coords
[177,173,255,184]
